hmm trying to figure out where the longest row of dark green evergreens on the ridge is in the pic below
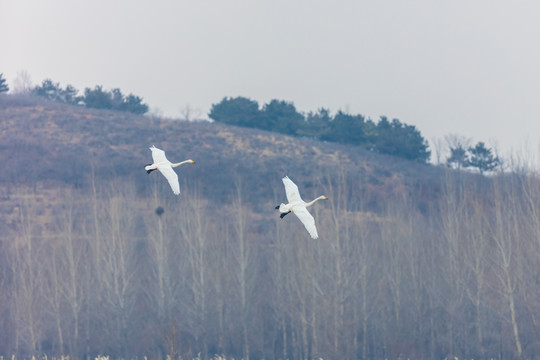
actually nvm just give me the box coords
[209,97,431,163]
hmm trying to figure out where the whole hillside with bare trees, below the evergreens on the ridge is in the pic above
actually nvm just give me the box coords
[0,94,540,360]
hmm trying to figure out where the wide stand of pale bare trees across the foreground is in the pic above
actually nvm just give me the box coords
[0,167,540,360]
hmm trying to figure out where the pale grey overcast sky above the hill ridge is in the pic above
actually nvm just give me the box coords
[0,0,540,160]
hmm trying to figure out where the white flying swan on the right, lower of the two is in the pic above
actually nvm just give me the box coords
[276,176,327,239]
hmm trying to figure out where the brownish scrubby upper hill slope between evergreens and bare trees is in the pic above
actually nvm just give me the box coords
[0,96,439,208]
